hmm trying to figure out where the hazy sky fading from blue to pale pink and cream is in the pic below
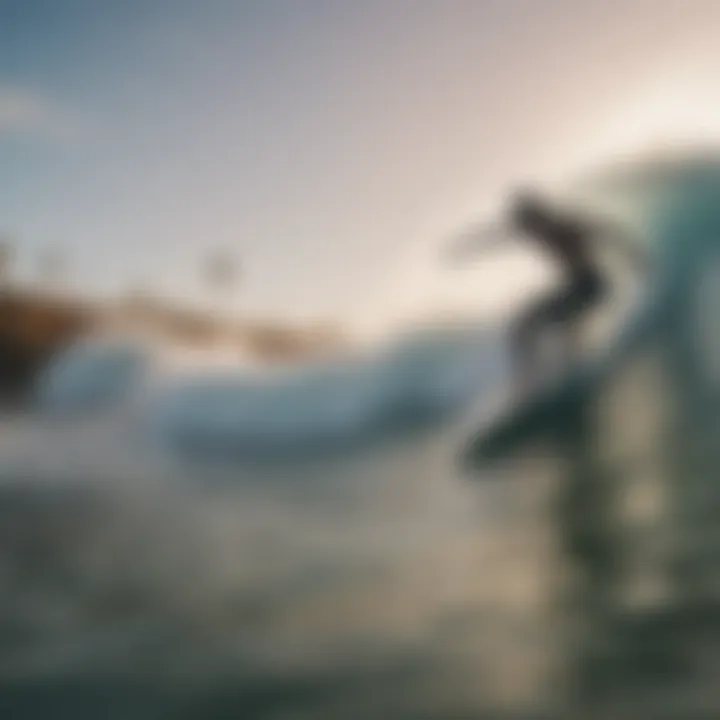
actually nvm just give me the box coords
[0,0,720,330]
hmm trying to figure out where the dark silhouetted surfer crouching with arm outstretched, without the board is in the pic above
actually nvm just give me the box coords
[451,192,644,392]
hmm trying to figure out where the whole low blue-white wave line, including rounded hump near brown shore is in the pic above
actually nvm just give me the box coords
[37,325,502,446]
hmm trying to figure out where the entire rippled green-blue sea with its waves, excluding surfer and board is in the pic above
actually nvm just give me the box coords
[0,149,720,719]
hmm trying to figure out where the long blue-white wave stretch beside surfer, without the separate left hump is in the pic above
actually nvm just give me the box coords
[156,327,502,447]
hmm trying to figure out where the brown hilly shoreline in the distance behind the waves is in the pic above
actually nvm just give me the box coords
[0,285,348,402]
